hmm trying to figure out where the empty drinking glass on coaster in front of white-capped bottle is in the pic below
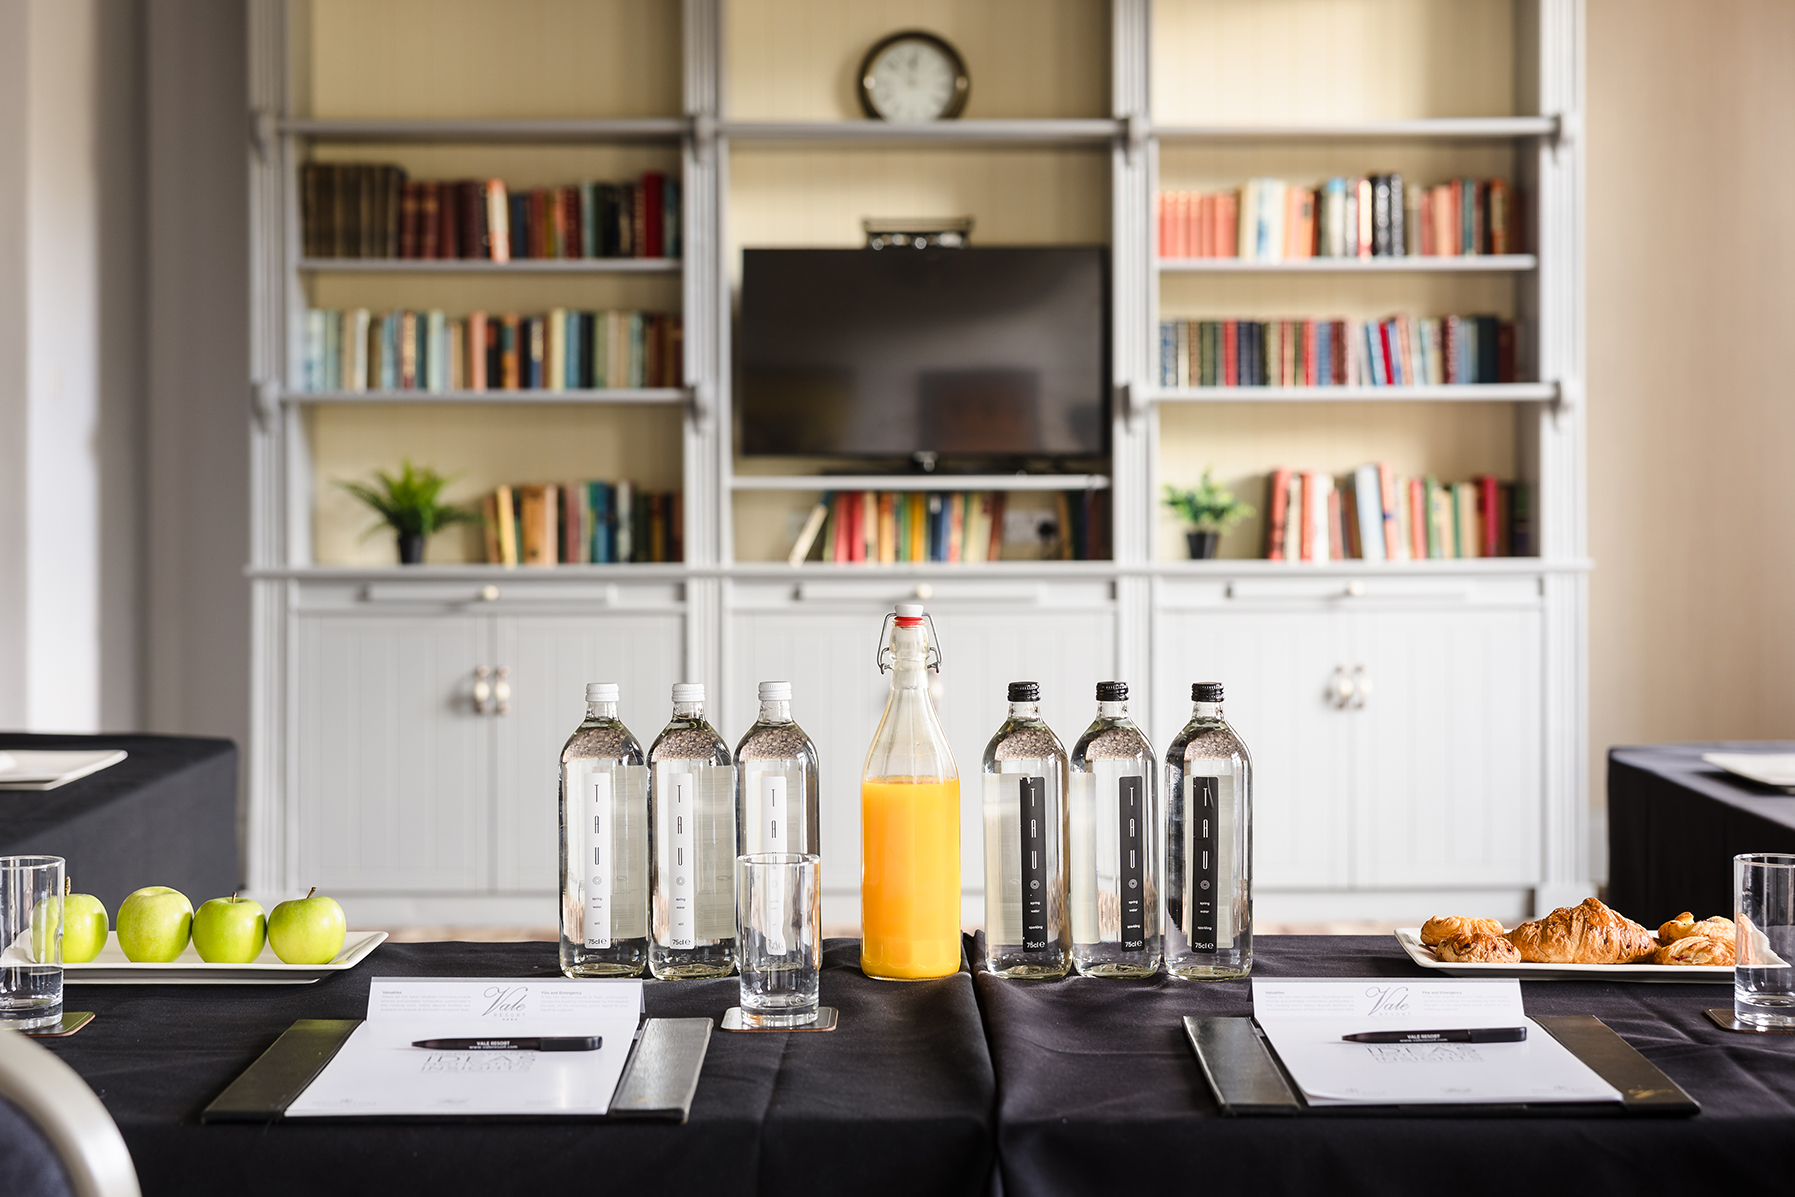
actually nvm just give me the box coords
[736,852,822,1027]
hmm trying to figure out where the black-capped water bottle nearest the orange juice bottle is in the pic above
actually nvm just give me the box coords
[984,682,1072,978]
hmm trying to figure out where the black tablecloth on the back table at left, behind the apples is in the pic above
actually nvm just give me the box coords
[0,732,242,919]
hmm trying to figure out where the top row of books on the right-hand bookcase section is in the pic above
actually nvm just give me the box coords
[1160,174,1519,262]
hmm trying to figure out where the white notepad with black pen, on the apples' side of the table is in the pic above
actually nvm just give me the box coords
[287,976,643,1118]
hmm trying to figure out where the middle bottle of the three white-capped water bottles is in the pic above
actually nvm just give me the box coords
[648,682,736,980]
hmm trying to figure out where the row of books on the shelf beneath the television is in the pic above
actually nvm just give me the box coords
[786,490,1109,565]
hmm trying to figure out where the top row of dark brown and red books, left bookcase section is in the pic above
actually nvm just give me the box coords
[300,162,682,262]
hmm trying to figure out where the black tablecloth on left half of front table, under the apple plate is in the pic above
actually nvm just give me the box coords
[41,940,994,1197]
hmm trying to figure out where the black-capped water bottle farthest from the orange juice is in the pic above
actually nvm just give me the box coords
[1165,682,1253,982]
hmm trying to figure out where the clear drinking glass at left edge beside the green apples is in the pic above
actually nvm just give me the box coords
[0,856,63,1030]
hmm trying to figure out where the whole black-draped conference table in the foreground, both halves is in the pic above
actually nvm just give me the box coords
[43,935,1795,1197]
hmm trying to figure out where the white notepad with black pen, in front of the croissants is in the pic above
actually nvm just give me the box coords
[1253,976,1621,1105]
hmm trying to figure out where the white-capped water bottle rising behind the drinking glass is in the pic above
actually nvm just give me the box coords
[736,682,822,856]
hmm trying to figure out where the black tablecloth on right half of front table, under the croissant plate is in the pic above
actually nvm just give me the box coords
[973,935,1795,1197]
